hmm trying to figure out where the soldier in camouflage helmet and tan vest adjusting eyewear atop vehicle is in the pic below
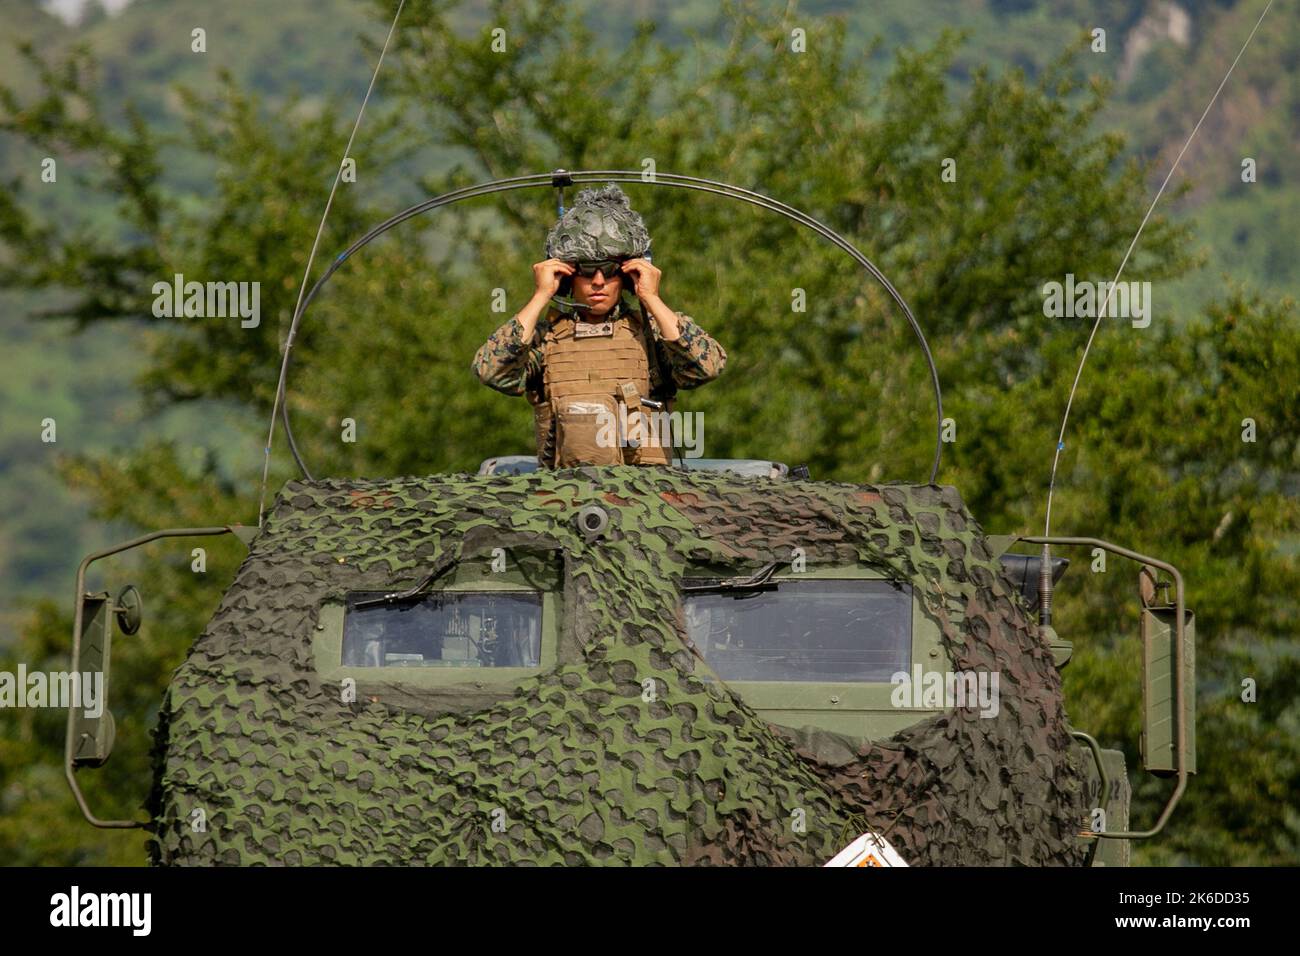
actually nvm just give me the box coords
[473,183,727,468]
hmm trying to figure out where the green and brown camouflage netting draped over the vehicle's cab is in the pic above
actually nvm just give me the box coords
[151,467,1086,865]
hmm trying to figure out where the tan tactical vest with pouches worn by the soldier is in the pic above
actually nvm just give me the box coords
[534,295,672,468]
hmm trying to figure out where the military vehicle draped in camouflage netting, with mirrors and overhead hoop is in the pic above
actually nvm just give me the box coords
[66,170,1195,866]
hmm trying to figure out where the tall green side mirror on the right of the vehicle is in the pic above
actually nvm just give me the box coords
[1138,564,1196,777]
